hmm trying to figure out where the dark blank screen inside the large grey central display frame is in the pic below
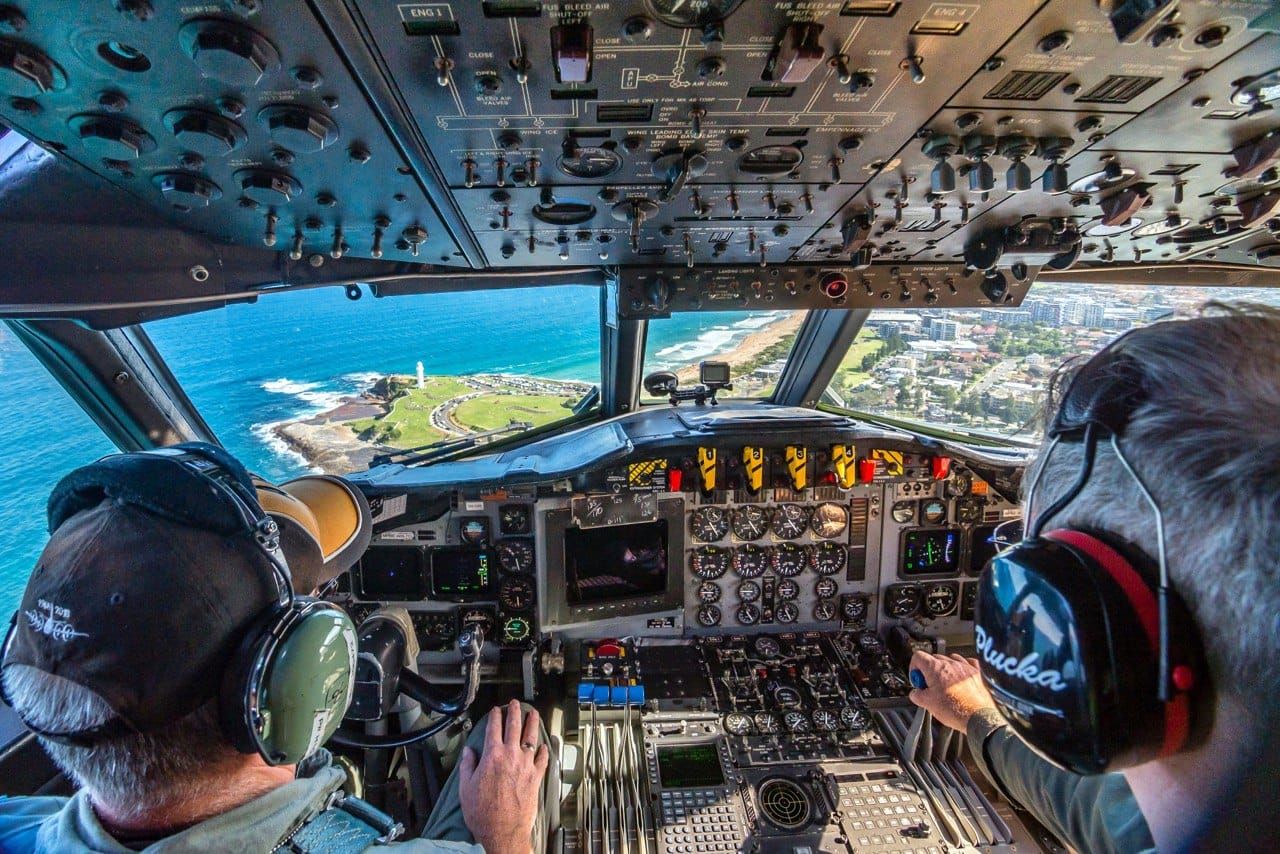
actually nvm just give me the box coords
[564,520,667,606]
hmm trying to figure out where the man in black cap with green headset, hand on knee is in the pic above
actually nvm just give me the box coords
[0,444,550,854]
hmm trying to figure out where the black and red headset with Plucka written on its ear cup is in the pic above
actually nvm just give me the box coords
[975,337,1207,773]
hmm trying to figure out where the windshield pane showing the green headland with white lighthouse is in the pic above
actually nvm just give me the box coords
[146,286,600,479]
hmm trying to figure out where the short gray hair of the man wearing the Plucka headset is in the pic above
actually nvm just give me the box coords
[1023,302,1280,723]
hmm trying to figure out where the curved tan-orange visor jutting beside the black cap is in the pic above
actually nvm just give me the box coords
[256,475,374,593]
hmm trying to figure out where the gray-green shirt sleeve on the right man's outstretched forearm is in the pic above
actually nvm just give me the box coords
[966,708,1156,854]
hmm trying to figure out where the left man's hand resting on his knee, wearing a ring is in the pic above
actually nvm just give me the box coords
[458,700,549,854]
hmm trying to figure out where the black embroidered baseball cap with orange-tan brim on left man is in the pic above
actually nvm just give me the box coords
[3,443,371,743]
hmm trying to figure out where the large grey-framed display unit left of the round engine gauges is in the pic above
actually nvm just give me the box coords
[543,498,685,627]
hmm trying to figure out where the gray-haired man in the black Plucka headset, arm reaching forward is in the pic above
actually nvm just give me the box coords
[910,303,1280,853]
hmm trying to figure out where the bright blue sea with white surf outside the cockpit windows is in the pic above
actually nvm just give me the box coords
[0,287,777,618]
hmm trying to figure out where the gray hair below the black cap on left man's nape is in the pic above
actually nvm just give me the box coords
[4,665,238,818]
